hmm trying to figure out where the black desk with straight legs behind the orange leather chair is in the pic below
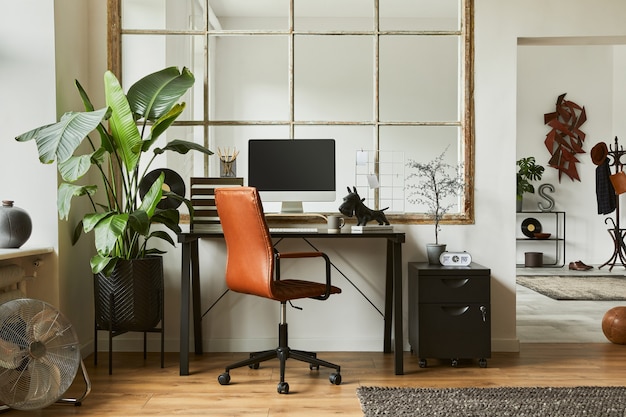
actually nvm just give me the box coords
[178,231,405,375]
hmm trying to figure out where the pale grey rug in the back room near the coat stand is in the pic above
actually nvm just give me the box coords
[516,276,626,301]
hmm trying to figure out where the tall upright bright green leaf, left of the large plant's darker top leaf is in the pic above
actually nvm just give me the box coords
[104,71,142,172]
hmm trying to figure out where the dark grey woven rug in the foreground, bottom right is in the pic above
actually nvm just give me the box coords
[357,387,626,417]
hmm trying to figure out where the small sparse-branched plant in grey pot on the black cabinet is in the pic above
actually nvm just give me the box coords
[406,148,465,265]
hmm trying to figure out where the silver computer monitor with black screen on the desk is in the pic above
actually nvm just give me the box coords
[248,139,336,213]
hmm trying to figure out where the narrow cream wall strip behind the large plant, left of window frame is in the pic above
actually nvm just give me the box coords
[49,0,107,354]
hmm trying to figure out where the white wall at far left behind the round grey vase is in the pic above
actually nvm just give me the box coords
[0,0,59,306]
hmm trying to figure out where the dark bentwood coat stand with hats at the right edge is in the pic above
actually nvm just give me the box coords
[596,136,626,271]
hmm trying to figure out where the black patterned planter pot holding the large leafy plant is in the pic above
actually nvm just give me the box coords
[94,256,163,332]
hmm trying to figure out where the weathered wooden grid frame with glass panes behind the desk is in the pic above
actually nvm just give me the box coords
[107,0,475,224]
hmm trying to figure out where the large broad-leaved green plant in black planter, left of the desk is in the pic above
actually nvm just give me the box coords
[16,67,212,331]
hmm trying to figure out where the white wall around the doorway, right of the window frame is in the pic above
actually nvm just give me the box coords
[475,0,626,350]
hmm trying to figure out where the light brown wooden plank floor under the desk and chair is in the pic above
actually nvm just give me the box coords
[6,343,626,417]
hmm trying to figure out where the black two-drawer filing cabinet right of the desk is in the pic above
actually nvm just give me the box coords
[409,262,491,368]
